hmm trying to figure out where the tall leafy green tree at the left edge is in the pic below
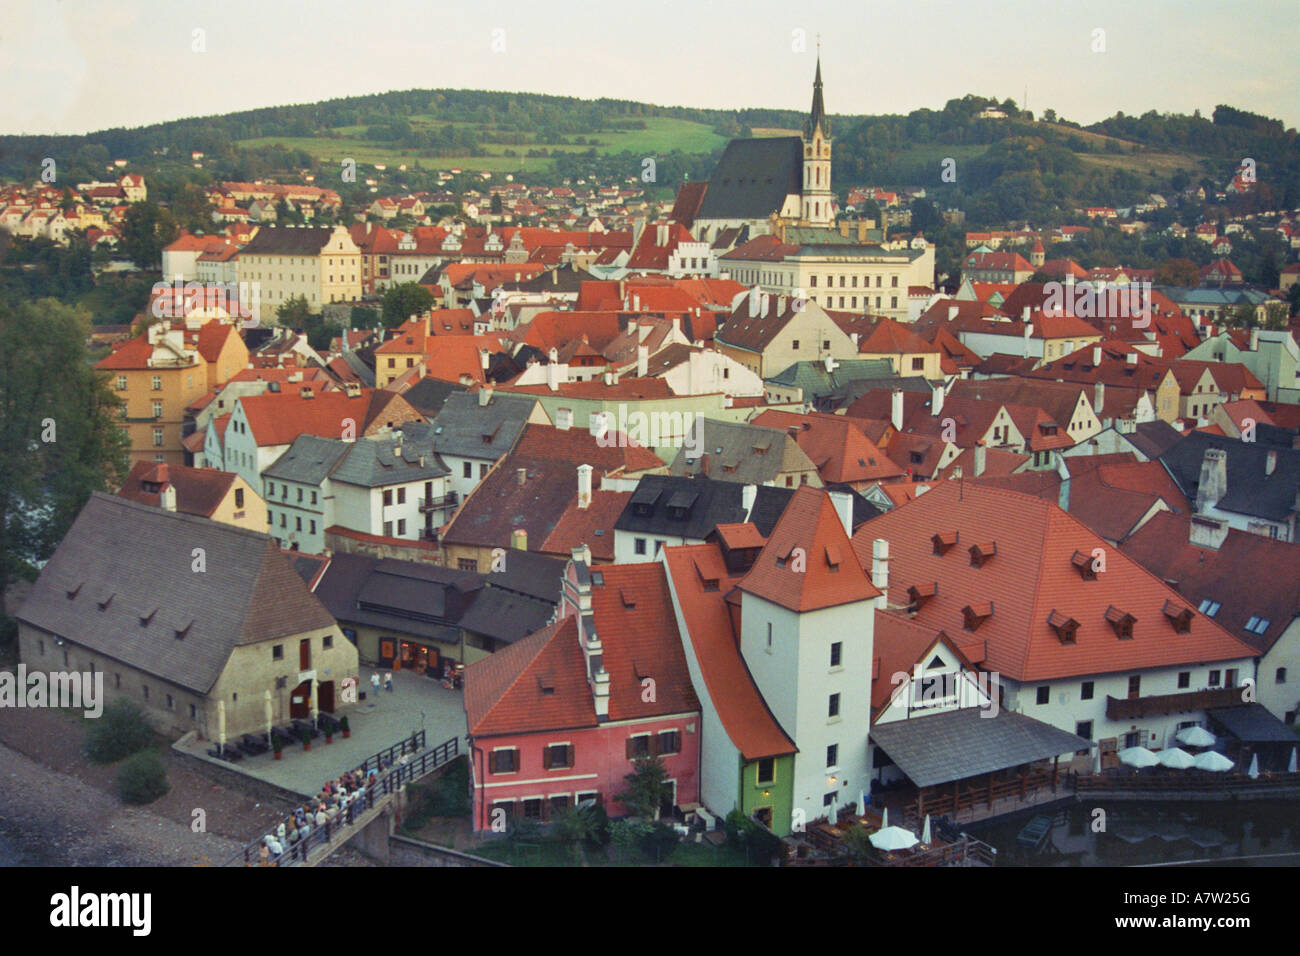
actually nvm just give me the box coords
[0,299,127,591]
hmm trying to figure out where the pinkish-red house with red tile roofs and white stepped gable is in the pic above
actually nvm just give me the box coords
[465,555,699,830]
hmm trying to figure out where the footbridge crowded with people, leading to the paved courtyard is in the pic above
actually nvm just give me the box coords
[222,731,460,866]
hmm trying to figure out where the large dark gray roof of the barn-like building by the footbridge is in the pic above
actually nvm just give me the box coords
[17,493,334,693]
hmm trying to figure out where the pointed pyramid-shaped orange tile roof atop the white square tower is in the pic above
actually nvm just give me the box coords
[738,485,880,611]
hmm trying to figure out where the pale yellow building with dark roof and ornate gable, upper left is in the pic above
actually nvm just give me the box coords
[239,226,361,312]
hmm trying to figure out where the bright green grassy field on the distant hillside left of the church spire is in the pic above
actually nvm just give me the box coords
[237,114,727,173]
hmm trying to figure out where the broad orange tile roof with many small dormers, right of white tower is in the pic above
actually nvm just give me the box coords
[853,481,1253,682]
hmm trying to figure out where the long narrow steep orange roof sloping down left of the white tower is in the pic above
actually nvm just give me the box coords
[663,546,798,761]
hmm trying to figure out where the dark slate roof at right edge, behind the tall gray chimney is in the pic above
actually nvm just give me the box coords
[1160,432,1300,522]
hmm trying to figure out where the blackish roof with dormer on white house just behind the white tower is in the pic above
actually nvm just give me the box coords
[614,475,794,541]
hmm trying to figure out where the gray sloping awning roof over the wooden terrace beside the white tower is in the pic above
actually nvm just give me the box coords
[871,708,1093,787]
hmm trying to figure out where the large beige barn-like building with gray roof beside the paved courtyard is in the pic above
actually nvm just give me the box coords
[17,493,358,741]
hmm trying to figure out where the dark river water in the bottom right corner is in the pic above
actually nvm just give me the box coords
[966,800,1300,866]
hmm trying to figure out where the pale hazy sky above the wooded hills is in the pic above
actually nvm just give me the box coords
[0,0,1300,133]
